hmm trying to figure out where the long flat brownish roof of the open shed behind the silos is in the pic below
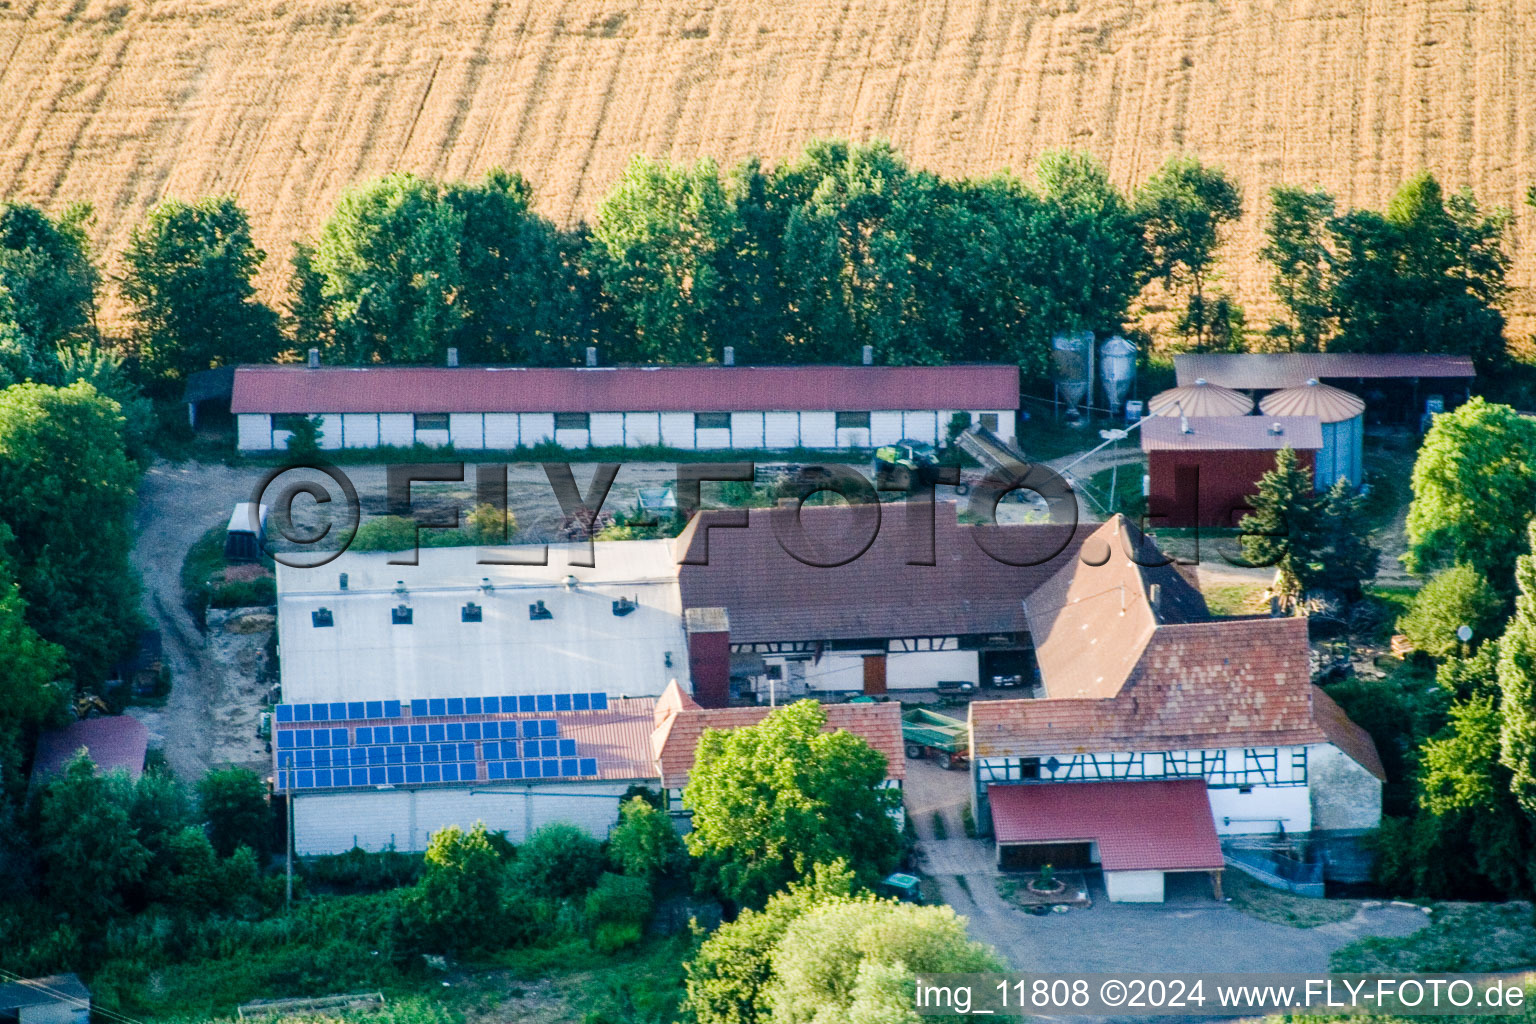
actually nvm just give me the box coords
[1174,352,1476,390]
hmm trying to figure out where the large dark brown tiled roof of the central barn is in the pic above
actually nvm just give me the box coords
[676,502,1094,643]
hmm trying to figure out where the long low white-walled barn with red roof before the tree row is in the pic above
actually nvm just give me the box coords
[230,364,1018,451]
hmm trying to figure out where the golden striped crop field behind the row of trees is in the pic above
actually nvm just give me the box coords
[0,0,1536,335]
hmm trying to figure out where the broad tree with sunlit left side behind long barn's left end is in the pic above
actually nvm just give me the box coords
[310,173,465,362]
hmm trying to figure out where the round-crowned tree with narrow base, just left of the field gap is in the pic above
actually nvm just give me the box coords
[1137,157,1243,350]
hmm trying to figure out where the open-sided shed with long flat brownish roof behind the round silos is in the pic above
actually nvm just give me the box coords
[1174,352,1476,425]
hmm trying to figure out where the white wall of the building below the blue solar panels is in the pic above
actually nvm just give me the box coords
[293,781,628,857]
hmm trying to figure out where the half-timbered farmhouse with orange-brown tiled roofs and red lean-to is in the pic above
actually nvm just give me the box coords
[969,517,1384,901]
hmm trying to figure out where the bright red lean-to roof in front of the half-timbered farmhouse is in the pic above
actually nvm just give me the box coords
[986,778,1223,870]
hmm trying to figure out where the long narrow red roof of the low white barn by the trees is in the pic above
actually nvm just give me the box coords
[230,364,1018,413]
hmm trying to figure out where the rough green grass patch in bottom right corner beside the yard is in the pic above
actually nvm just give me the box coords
[1329,901,1536,973]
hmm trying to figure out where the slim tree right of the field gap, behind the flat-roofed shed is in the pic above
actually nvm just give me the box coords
[1260,186,1335,352]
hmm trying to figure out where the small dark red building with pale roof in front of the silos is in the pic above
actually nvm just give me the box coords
[1141,416,1324,527]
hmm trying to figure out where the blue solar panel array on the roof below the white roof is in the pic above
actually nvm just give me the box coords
[275,692,608,789]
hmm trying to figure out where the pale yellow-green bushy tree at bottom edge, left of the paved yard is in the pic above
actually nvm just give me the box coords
[766,901,1001,1024]
